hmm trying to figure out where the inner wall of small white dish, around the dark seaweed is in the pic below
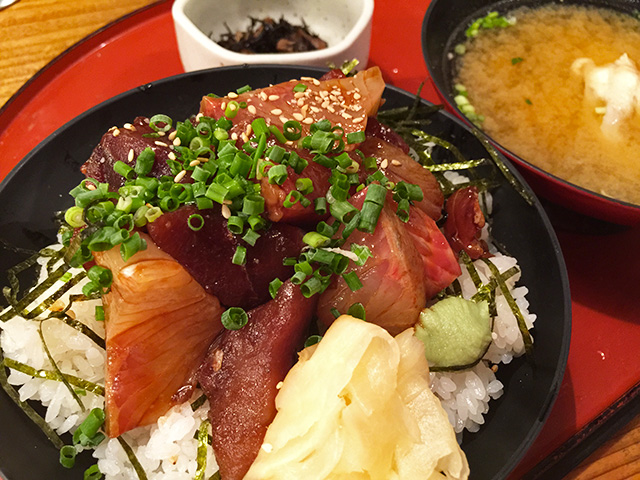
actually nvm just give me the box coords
[184,0,367,47]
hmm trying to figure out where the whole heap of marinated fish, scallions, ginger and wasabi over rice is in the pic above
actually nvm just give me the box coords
[0,68,535,480]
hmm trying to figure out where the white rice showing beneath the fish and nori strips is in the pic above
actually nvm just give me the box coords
[0,204,535,474]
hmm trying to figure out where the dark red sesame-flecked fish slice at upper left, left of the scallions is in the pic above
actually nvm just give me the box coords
[80,117,178,190]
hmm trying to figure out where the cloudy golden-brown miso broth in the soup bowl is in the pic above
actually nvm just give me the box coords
[457,5,640,204]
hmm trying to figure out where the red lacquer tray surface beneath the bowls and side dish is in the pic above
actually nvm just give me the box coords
[0,0,640,478]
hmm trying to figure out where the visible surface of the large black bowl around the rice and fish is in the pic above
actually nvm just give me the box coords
[0,66,571,480]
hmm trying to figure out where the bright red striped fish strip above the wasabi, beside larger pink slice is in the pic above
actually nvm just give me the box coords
[405,208,461,299]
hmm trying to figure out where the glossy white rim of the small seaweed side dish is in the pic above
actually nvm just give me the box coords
[171,0,374,64]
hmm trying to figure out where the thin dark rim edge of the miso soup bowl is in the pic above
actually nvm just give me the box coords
[422,0,640,214]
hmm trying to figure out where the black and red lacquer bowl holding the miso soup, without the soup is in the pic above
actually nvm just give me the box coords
[422,0,640,225]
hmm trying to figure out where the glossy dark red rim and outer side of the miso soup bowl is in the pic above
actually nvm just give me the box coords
[421,0,640,225]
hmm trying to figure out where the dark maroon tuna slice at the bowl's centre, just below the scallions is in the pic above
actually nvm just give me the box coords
[147,206,304,308]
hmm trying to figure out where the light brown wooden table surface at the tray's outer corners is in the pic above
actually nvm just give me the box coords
[0,0,640,480]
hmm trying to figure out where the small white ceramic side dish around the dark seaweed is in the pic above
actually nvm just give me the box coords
[171,0,374,71]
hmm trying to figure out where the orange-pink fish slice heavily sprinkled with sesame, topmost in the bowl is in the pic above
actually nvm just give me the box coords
[200,67,385,149]
